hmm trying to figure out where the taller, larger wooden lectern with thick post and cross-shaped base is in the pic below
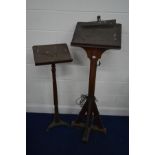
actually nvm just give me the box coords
[71,16,121,142]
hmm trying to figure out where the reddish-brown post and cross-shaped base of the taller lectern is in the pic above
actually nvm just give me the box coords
[72,47,107,142]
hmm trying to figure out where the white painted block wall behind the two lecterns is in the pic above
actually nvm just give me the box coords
[26,0,129,115]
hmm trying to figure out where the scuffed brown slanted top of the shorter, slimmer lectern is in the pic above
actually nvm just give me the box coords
[32,44,73,65]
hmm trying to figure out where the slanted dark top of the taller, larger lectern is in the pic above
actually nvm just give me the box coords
[71,20,121,49]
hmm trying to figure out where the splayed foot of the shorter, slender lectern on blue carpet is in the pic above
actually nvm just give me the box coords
[46,118,69,131]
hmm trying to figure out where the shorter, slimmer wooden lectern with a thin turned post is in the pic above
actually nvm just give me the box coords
[33,44,73,131]
